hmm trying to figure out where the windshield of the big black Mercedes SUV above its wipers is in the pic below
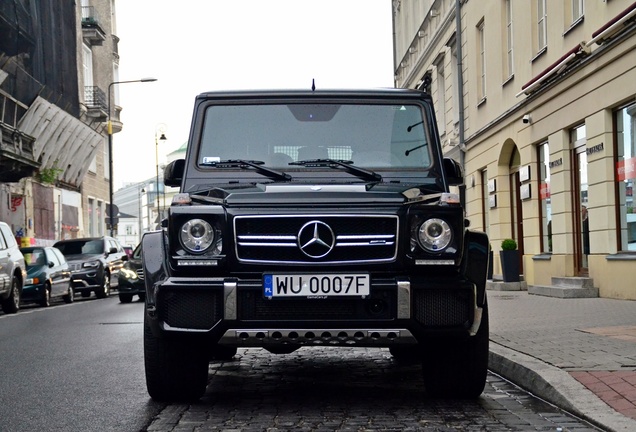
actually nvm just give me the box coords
[198,104,432,171]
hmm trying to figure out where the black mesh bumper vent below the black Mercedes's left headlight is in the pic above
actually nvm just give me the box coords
[157,288,223,330]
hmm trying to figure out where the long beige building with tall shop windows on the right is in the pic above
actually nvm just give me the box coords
[393,0,636,299]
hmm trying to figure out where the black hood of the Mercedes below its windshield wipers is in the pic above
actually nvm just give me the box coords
[190,183,444,206]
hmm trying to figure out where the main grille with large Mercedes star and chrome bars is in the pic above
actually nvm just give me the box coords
[234,214,399,264]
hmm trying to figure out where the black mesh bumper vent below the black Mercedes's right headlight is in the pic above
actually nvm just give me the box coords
[413,289,473,327]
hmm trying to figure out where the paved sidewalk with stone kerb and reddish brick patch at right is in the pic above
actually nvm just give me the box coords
[488,290,636,432]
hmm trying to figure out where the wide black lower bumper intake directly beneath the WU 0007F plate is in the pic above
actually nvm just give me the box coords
[238,291,396,321]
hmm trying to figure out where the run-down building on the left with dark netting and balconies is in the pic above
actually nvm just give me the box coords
[0,0,126,245]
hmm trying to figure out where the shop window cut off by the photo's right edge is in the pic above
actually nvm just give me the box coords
[615,104,636,252]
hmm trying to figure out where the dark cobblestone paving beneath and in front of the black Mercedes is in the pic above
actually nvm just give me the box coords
[147,347,598,432]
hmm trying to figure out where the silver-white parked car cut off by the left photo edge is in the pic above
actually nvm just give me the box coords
[0,222,26,313]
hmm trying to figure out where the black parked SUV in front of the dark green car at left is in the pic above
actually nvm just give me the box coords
[53,236,128,298]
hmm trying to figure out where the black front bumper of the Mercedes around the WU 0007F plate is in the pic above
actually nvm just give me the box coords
[147,277,481,346]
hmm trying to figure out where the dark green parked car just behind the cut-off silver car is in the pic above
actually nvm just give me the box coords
[20,246,75,307]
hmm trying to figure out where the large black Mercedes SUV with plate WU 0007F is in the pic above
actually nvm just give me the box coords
[142,89,490,400]
